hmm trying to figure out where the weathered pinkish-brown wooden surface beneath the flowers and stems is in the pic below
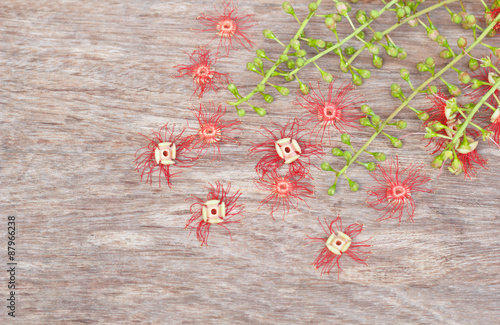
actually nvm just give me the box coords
[0,0,500,324]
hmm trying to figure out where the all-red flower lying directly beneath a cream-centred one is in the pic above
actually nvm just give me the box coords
[254,172,314,219]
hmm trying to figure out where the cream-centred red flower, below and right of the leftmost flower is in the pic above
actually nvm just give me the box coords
[186,181,244,246]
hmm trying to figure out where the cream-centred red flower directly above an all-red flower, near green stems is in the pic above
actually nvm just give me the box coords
[249,118,323,176]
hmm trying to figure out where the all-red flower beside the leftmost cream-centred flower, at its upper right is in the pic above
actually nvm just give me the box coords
[189,101,241,159]
